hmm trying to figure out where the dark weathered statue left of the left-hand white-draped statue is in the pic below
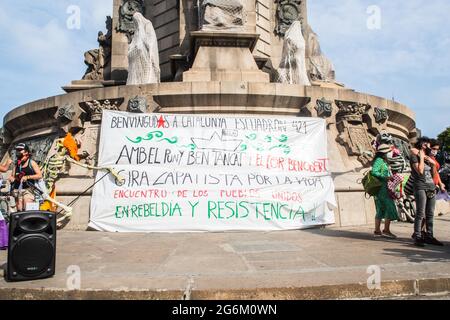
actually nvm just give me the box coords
[83,16,112,80]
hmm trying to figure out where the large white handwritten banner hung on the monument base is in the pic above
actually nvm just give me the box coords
[89,111,336,232]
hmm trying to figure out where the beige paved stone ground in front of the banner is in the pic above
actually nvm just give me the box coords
[0,214,450,299]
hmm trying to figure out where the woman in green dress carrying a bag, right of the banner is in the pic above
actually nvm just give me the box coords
[372,144,398,239]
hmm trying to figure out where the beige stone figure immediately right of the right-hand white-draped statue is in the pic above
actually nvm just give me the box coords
[306,25,336,82]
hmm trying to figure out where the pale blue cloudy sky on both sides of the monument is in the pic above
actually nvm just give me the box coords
[0,0,450,137]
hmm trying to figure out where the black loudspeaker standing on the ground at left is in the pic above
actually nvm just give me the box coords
[6,211,56,281]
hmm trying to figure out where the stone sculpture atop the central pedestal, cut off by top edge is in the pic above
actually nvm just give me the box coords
[199,0,245,30]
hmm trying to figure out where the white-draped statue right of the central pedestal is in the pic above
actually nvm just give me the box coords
[278,21,311,86]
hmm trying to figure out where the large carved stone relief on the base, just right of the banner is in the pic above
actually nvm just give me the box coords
[336,100,374,165]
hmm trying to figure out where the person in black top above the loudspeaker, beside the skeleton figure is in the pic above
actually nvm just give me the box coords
[9,143,42,211]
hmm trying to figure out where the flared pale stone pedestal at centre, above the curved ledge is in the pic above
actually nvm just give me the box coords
[183,31,270,82]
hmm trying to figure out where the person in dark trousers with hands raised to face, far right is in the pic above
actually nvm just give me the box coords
[410,137,443,247]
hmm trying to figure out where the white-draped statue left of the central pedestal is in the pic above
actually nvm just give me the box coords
[127,12,160,85]
